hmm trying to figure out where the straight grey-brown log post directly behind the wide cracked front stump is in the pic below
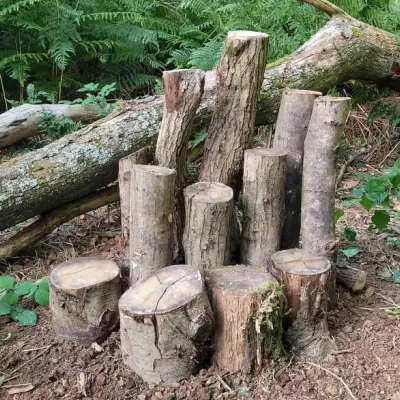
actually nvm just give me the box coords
[129,165,175,285]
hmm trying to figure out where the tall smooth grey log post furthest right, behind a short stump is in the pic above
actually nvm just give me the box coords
[301,96,350,310]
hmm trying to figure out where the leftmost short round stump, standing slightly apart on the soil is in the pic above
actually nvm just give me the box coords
[49,257,121,343]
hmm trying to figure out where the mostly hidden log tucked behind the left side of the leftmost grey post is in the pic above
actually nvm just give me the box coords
[118,146,153,289]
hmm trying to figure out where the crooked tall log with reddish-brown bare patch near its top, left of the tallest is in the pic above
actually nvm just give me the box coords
[156,69,205,261]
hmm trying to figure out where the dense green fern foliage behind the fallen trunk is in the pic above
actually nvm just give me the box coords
[0,0,400,106]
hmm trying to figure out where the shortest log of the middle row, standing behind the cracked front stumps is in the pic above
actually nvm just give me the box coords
[183,182,233,271]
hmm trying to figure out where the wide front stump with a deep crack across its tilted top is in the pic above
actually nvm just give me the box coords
[119,265,213,384]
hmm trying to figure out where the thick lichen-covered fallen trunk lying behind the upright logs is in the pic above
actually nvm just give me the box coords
[0,1,400,230]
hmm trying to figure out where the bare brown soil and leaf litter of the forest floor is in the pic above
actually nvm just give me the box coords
[0,109,400,400]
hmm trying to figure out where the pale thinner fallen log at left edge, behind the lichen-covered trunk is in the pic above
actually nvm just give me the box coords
[0,104,101,149]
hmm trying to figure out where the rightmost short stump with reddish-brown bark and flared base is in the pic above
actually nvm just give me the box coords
[270,249,336,358]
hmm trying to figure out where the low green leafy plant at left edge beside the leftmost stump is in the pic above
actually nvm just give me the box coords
[0,276,50,326]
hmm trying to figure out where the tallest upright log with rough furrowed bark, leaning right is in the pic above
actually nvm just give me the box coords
[199,31,268,189]
